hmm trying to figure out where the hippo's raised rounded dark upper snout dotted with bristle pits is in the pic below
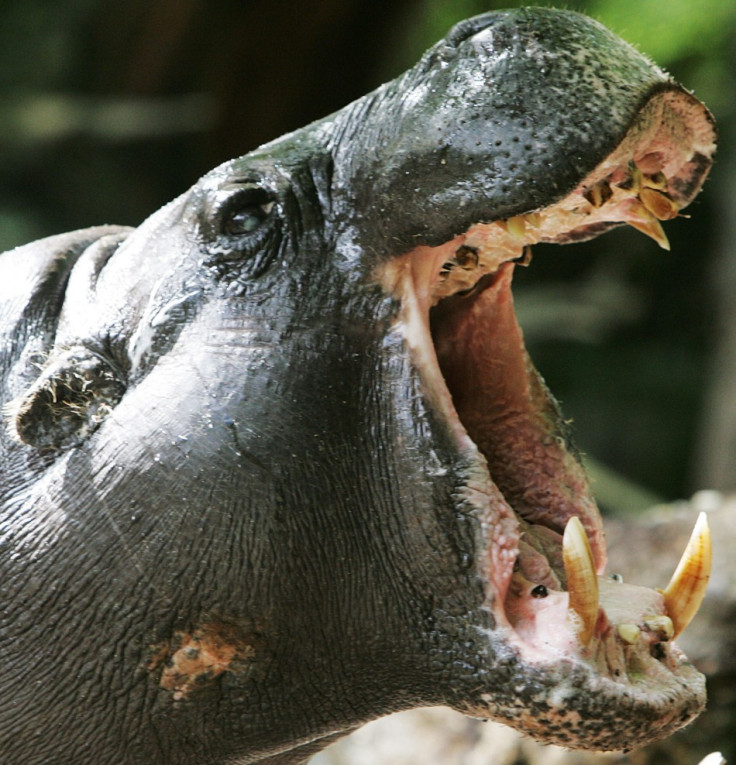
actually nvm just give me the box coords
[330,8,713,256]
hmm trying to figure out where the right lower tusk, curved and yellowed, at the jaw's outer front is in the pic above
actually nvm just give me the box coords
[662,513,713,637]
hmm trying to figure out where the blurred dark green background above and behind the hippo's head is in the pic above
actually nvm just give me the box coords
[0,0,736,512]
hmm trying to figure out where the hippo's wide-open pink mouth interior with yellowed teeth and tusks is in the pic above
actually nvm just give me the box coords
[382,90,714,700]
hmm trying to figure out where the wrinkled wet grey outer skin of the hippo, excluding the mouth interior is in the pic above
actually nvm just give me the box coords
[0,10,716,765]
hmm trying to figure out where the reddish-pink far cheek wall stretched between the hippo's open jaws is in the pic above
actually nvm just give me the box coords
[431,263,605,573]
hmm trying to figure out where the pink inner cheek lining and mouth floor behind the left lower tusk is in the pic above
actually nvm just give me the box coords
[430,256,606,655]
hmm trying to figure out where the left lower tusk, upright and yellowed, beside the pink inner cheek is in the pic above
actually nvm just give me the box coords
[562,516,598,645]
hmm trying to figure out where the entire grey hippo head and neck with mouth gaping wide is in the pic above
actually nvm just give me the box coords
[0,9,714,763]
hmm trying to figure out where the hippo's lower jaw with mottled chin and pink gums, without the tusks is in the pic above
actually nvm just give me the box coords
[440,396,706,751]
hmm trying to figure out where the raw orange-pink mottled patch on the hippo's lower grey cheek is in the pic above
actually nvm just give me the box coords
[148,622,256,701]
